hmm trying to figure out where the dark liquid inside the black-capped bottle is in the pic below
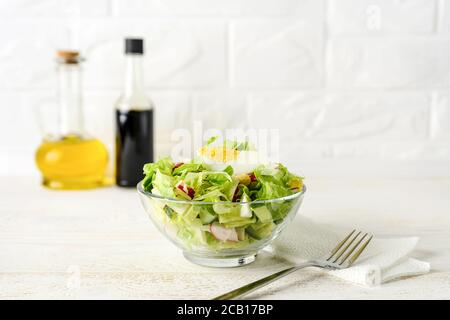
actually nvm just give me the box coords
[116,110,153,187]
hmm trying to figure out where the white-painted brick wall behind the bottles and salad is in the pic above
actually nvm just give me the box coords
[0,0,450,176]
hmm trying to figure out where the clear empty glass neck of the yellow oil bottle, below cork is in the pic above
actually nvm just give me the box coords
[58,63,84,135]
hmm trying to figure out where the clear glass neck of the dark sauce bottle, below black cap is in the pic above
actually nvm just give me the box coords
[124,54,145,97]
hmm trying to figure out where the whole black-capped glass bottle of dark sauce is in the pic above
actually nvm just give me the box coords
[115,38,154,187]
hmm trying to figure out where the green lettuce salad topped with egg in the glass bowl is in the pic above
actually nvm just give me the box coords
[142,138,303,250]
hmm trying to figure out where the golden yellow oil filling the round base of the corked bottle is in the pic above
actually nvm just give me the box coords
[36,135,108,189]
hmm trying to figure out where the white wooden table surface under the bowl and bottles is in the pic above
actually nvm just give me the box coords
[0,177,450,299]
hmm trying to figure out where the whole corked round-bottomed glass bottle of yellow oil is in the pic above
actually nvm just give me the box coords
[36,51,108,189]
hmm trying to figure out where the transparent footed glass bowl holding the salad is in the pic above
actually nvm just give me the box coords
[137,182,306,267]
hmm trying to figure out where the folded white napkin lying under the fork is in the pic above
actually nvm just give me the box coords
[272,217,430,286]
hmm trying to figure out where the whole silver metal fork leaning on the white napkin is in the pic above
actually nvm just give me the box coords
[213,230,373,300]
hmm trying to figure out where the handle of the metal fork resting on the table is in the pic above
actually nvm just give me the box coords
[212,261,316,300]
